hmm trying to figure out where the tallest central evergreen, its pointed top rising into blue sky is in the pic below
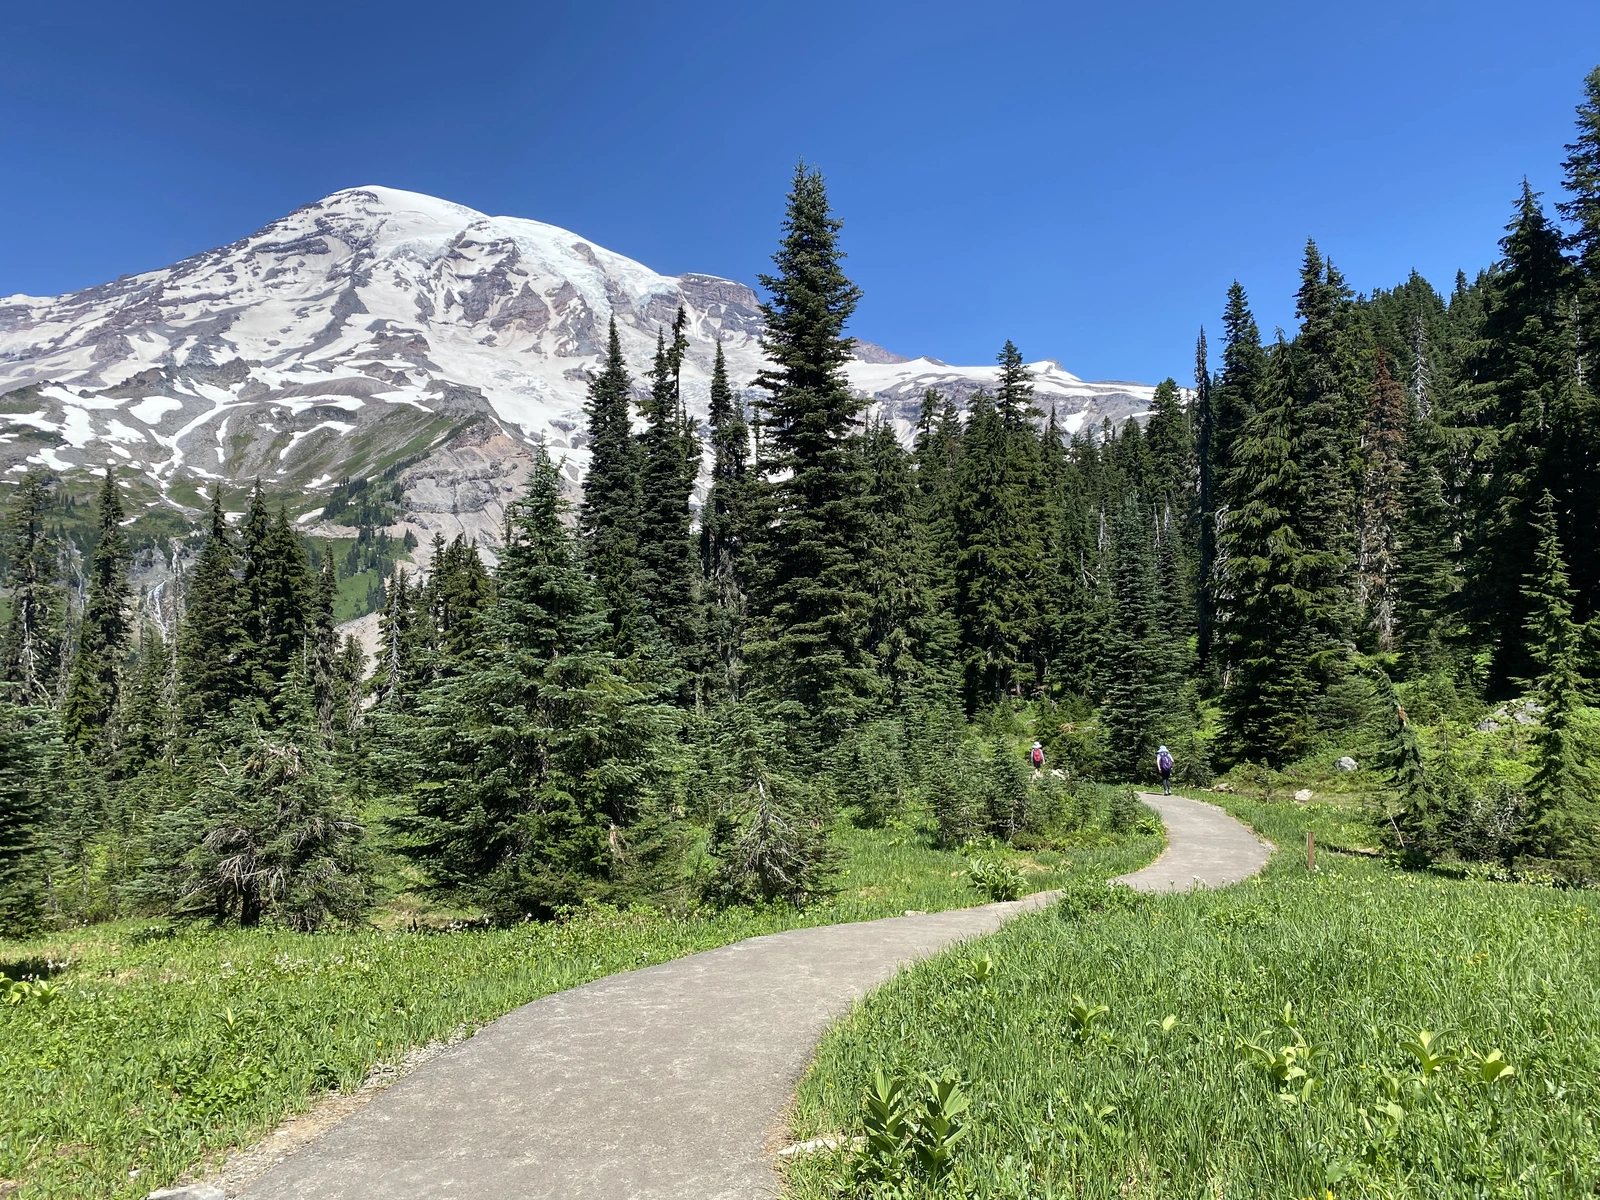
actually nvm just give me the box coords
[746,163,875,747]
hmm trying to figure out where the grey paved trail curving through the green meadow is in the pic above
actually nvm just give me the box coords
[236,794,1267,1200]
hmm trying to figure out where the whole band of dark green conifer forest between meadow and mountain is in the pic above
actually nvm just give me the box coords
[0,72,1600,934]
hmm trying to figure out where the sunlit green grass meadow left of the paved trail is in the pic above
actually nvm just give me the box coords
[0,829,1157,1200]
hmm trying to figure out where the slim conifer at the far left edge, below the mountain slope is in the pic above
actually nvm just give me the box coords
[3,467,66,706]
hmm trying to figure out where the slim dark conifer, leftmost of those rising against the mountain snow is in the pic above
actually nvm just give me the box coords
[578,317,640,645]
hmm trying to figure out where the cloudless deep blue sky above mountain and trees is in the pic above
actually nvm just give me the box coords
[0,0,1600,381]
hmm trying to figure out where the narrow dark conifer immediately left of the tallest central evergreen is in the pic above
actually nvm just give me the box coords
[701,341,754,699]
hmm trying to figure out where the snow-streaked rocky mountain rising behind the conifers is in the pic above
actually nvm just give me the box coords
[0,187,1152,538]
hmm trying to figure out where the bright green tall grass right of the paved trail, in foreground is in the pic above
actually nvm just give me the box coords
[789,851,1600,1200]
